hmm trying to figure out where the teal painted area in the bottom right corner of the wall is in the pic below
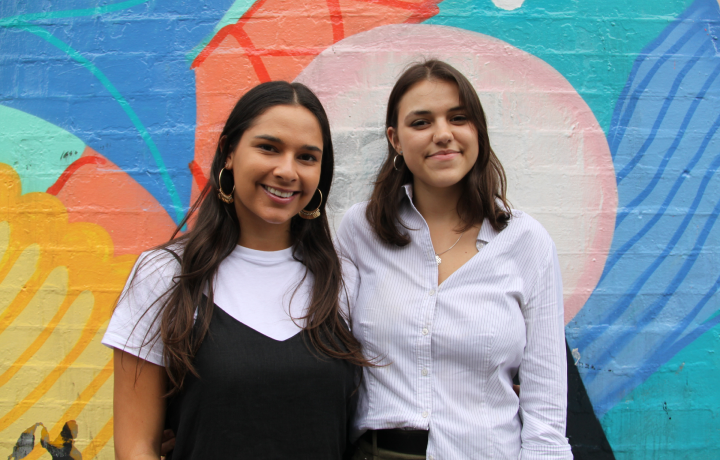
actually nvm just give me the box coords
[602,326,720,460]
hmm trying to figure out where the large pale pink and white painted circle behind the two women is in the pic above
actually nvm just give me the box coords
[296,25,617,323]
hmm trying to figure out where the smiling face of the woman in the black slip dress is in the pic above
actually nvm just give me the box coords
[225,105,323,233]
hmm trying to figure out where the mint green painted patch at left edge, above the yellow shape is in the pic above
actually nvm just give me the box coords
[0,105,85,193]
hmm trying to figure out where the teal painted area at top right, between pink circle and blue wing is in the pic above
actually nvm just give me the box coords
[427,0,692,133]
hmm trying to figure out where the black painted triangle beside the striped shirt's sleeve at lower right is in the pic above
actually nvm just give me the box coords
[565,341,615,460]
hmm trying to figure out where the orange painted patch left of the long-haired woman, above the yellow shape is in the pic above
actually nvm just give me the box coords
[53,147,175,255]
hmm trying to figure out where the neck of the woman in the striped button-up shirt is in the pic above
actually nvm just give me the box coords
[413,181,462,228]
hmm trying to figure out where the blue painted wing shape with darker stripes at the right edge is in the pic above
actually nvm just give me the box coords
[566,0,720,418]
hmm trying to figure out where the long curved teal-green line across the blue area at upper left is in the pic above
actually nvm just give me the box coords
[14,24,183,222]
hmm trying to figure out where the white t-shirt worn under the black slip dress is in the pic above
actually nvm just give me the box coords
[102,246,356,366]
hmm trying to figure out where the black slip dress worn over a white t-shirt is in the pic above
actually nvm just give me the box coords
[166,306,359,460]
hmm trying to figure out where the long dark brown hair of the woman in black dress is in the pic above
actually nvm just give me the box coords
[126,81,368,394]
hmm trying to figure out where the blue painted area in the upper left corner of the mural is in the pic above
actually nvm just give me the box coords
[0,0,233,219]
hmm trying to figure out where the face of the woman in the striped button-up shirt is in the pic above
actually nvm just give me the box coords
[387,80,479,189]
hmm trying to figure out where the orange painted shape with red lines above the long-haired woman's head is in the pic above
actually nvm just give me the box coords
[192,0,440,205]
